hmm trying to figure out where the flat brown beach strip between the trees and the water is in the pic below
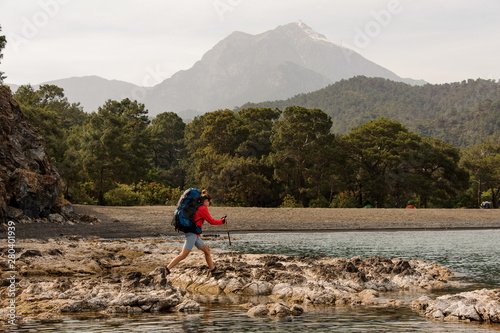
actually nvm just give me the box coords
[10,205,500,239]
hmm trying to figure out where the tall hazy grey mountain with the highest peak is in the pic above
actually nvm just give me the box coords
[144,21,424,113]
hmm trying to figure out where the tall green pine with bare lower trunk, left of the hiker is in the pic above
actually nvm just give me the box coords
[81,98,150,205]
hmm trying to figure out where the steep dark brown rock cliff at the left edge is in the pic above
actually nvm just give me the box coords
[0,87,60,220]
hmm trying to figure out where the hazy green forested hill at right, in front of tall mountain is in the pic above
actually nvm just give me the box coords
[237,76,500,148]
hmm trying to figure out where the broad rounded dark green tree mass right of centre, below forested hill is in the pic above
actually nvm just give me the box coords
[344,118,468,207]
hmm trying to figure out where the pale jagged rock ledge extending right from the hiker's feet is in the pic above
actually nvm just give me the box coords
[169,256,452,306]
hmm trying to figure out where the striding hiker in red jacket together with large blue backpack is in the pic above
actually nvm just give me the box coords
[165,188,227,275]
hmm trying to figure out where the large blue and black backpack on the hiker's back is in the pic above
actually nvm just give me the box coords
[172,188,203,235]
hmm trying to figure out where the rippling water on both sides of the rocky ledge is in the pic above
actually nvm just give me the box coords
[10,230,500,333]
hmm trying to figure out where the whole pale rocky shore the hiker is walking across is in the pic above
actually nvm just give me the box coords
[0,236,462,323]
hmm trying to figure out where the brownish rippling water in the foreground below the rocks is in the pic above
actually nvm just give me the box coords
[10,306,500,333]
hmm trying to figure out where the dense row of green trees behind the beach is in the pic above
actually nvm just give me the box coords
[10,85,500,208]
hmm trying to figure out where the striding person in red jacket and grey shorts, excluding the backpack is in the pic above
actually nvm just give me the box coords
[166,190,227,275]
